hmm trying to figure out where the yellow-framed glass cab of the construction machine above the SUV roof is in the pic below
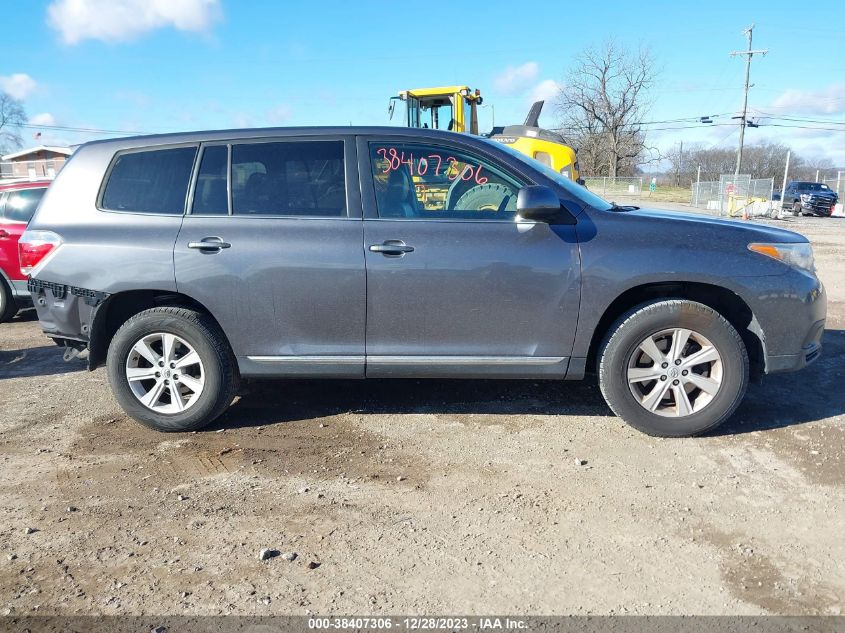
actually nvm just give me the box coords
[389,86,483,134]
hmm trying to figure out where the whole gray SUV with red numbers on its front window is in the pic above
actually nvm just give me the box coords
[20,127,826,436]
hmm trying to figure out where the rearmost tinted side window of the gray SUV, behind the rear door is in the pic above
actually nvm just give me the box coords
[101,147,197,215]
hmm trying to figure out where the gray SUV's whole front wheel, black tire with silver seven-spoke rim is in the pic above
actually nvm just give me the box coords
[599,299,749,437]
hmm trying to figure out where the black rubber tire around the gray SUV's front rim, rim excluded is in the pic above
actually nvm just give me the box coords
[598,299,749,437]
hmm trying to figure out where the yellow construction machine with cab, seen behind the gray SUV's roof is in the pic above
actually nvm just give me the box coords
[388,86,581,182]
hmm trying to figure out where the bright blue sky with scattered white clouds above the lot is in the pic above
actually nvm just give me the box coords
[0,0,845,167]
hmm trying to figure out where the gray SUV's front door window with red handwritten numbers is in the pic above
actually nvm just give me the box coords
[370,143,522,221]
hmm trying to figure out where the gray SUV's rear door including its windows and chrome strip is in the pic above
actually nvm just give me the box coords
[174,136,366,377]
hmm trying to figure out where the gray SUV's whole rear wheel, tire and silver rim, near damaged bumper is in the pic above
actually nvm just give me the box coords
[106,307,238,432]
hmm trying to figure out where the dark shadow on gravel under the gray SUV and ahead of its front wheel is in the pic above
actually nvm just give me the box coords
[213,330,845,435]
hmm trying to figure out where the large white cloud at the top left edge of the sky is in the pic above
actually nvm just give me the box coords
[47,0,221,44]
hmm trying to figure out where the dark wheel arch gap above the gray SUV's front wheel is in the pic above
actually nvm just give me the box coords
[587,281,766,379]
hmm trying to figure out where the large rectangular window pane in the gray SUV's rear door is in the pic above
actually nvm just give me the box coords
[232,141,346,218]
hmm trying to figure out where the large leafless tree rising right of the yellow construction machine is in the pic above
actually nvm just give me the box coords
[557,42,657,176]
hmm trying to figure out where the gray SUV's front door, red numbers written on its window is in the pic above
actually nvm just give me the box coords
[358,137,580,377]
